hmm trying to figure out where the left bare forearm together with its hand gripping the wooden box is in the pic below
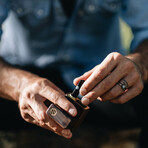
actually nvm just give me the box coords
[0,59,77,138]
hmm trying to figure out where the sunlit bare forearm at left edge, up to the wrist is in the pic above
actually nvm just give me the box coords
[0,58,38,101]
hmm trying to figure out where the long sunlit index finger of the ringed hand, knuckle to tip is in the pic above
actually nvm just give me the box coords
[80,55,117,96]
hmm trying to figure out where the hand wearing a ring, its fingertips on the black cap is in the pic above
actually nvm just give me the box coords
[74,52,144,105]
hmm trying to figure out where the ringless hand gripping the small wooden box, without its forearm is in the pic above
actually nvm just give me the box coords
[19,77,77,138]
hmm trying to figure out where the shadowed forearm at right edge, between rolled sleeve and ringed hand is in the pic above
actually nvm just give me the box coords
[127,39,148,83]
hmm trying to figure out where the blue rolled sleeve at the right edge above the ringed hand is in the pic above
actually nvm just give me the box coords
[121,0,148,52]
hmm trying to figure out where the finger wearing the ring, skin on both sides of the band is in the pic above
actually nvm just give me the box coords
[101,71,140,101]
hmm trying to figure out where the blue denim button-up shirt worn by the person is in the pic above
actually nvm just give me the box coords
[0,0,148,86]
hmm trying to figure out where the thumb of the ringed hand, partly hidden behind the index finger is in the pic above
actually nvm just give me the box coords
[73,66,97,85]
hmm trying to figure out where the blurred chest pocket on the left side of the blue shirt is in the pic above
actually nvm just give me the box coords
[11,0,51,20]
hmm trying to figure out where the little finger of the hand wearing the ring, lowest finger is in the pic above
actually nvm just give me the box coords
[110,81,143,104]
